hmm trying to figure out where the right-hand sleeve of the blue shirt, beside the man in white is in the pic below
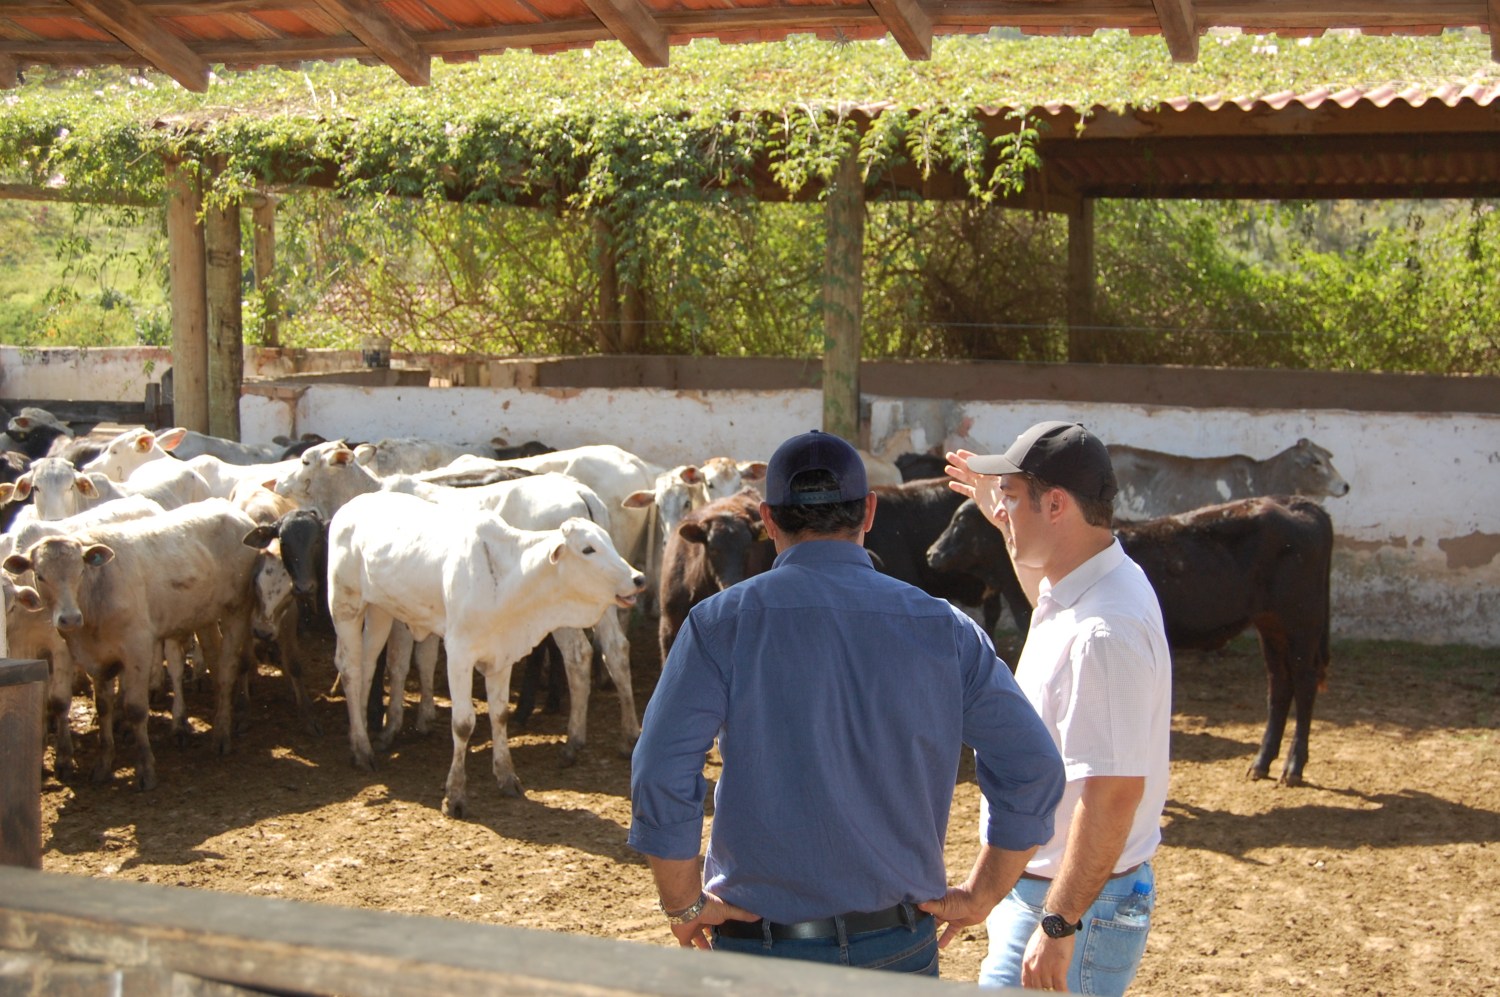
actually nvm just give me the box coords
[963,640,1067,852]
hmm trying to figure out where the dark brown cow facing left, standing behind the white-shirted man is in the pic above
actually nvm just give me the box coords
[929,496,1334,786]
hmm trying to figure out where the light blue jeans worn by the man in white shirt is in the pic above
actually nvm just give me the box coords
[980,862,1157,994]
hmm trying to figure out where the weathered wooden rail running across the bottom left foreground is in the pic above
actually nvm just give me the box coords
[0,869,996,997]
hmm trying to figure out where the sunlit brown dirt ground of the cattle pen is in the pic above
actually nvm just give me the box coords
[32,625,1500,994]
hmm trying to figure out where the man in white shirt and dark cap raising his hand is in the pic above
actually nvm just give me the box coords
[948,421,1172,994]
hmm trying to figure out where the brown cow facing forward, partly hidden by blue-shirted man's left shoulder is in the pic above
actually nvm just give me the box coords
[657,489,776,661]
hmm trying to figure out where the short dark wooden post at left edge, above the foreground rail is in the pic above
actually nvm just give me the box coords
[0,658,47,870]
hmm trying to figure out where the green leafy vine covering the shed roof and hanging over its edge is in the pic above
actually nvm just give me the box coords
[0,31,1497,213]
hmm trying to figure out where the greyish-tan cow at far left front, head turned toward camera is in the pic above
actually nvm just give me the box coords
[5,499,255,789]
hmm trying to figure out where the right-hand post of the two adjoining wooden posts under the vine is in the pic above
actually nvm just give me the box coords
[203,166,245,439]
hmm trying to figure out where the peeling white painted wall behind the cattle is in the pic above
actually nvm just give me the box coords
[0,348,1500,646]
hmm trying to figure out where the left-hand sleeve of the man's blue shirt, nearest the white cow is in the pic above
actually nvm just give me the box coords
[629,615,729,859]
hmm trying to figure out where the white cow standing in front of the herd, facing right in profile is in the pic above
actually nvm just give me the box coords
[329,492,645,817]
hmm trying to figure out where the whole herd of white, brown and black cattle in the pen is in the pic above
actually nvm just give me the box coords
[0,409,1349,816]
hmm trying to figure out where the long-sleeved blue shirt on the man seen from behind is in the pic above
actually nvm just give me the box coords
[630,540,1064,922]
